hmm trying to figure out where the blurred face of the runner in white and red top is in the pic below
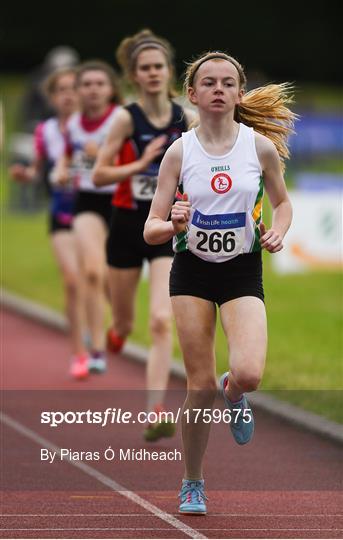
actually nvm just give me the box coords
[78,70,113,110]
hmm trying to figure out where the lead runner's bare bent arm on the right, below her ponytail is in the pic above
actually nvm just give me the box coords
[256,134,292,253]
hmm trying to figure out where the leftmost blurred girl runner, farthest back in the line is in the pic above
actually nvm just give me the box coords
[11,69,88,379]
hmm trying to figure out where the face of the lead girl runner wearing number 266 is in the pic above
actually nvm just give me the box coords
[188,60,243,114]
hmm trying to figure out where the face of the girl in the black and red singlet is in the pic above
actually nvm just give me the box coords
[134,49,171,94]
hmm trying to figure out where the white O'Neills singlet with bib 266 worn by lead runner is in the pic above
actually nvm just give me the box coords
[173,123,263,263]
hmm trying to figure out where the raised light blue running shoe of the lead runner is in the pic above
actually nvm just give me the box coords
[219,372,255,444]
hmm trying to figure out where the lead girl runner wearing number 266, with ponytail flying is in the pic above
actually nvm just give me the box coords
[144,52,294,514]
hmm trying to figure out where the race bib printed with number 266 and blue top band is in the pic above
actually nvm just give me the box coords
[188,210,246,262]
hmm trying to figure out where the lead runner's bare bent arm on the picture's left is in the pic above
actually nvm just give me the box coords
[144,139,182,245]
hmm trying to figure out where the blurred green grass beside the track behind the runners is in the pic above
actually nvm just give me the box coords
[0,77,343,421]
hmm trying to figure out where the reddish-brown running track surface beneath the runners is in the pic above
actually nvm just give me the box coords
[0,311,343,538]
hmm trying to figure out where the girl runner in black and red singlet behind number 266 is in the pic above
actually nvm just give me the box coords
[93,30,193,441]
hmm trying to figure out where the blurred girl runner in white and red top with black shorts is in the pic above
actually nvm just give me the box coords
[57,61,121,373]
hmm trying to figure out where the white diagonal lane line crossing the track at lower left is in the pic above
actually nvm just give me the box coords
[0,411,206,538]
